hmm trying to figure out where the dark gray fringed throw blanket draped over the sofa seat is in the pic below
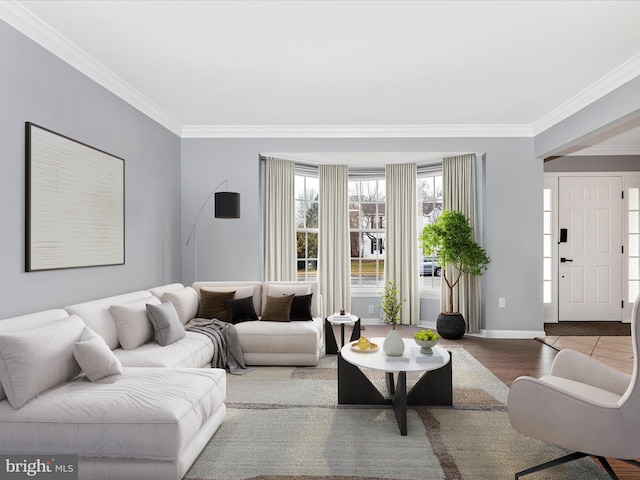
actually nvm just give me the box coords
[185,318,254,375]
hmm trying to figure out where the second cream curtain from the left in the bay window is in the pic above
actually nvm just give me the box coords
[318,165,351,315]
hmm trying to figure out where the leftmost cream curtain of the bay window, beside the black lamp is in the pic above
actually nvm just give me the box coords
[264,158,296,281]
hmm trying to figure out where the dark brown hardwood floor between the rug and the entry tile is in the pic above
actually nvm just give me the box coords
[344,325,640,480]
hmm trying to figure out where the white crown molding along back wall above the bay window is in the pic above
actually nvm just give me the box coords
[181,125,533,138]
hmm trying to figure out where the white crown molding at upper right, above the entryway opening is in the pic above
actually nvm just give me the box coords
[532,54,640,135]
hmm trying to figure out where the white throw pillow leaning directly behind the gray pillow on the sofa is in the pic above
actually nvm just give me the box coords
[109,296,160,350]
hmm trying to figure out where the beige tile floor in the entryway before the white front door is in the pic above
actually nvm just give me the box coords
[545,336,633,374]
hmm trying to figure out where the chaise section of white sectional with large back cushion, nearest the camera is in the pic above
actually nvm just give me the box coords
[0,310,226,480]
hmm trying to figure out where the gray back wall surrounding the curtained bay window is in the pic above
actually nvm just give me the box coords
[182,138,543,331]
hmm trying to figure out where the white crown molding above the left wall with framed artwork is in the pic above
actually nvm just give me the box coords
[0,1,182,135]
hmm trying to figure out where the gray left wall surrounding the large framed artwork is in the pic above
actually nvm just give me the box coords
[0,22,180,318]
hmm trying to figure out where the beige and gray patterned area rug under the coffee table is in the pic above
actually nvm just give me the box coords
[185,347,608,480]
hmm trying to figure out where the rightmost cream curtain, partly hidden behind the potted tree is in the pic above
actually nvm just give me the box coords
[440,154,480,333]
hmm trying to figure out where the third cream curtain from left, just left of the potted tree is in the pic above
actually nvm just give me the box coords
[384,163,420,325]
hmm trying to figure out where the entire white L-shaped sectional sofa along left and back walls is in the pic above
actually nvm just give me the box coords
[0,282,323,480]
